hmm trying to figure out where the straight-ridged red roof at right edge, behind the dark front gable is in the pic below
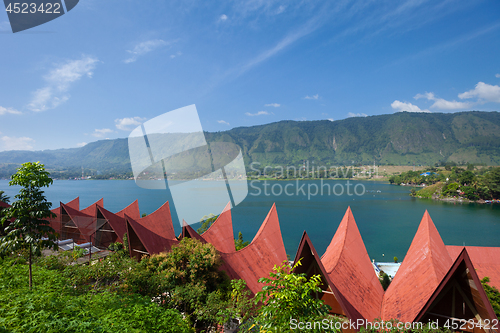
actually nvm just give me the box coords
[446,246,500,290]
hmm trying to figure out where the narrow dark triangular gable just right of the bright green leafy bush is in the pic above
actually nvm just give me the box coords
[294,231,361,319]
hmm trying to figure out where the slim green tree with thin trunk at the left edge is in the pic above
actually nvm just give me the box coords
[0,162,57,289]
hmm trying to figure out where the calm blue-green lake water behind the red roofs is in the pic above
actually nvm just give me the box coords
[0,180,500,261]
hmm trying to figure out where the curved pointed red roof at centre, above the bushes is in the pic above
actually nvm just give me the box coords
[221,204,287,294]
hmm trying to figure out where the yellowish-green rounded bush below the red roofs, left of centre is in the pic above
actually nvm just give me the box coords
[132,238,230,330]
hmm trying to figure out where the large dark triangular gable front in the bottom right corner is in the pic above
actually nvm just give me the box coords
[414,247,496,332]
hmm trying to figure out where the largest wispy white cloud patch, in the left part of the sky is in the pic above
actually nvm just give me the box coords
[28,56,98,111]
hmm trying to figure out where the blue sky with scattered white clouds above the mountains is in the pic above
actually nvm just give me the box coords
[0,0,500,150]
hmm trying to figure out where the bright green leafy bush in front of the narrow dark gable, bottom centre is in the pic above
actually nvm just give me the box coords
[255,260,331,332]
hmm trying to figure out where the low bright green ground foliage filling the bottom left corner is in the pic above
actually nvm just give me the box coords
[0,258,194,333]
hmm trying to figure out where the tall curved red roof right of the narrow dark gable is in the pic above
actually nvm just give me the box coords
[321,207,384,321]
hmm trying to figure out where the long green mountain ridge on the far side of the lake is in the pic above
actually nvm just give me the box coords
[0,111,500,177]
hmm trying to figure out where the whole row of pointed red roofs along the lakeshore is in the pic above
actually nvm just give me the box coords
[0,198,500,331]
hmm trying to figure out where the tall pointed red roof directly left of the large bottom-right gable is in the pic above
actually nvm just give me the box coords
[382,211,453,322]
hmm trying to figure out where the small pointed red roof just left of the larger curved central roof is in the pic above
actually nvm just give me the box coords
[201,202,236,252]
